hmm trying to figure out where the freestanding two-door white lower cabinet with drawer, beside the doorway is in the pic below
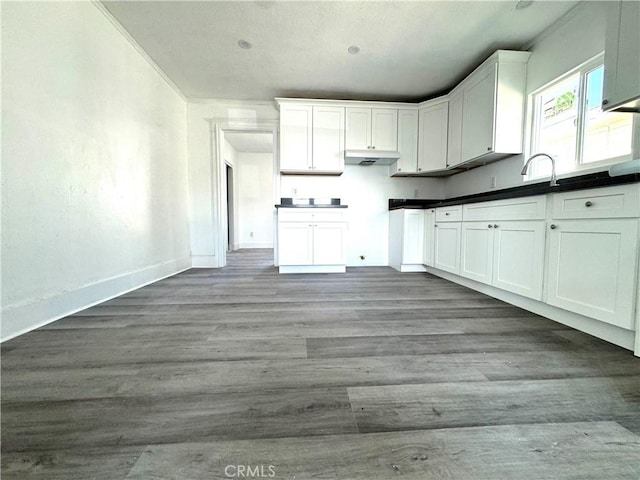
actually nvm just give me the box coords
[278,209,347,273]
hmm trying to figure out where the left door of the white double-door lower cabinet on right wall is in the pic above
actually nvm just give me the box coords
[460,222,493,284]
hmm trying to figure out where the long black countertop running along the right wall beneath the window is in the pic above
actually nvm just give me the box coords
[389,172,640,210]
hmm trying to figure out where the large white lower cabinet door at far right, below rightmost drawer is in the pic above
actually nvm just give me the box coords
[546,220,638,329]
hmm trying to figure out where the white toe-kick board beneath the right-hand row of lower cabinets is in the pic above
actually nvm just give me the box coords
[427,267,635,351]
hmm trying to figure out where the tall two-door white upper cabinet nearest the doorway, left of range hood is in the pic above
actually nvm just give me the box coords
[280,102,345,175]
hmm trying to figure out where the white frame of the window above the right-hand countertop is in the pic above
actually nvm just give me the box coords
[523,52,640,182]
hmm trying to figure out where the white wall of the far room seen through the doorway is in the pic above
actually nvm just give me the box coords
[234,152,276,248]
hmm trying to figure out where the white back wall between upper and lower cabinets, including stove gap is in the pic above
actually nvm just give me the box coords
[280,165,444,266]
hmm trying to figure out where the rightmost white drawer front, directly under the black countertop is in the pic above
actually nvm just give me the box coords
[552,183,640,219]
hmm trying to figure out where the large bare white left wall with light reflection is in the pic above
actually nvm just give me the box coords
[2,2,190,339]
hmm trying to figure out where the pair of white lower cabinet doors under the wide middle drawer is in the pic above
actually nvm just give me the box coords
[460,221,545,300]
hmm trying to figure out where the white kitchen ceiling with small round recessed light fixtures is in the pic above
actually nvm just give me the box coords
[103,0,578,101]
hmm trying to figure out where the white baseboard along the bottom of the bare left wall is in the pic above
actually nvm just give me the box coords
[0,257,191,342]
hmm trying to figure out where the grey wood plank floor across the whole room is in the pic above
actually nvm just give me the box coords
[1,250,640,480]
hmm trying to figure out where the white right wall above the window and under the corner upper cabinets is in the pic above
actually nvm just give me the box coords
[445,2,624,198]
